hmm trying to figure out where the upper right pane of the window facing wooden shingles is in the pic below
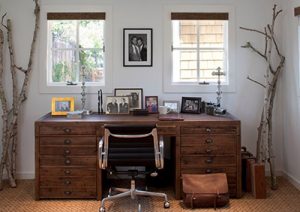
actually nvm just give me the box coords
[199,21,225,48]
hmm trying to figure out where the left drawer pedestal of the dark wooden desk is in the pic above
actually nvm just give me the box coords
[36,122,97,199]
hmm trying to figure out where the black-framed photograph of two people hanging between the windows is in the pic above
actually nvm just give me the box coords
[123,28,153,67]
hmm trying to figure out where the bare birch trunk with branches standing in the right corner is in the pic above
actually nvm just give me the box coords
[240,4,285,189]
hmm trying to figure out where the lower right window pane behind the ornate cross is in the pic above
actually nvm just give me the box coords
[199,50,226,82]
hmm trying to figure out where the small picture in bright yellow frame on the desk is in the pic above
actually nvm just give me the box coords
[51,97,74,115]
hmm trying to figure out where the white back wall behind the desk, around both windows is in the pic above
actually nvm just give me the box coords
[0,0,286,179]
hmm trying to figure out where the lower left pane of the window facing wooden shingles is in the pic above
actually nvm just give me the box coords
[173,50,197,82]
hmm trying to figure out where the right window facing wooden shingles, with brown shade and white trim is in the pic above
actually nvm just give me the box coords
[164,6,235,93]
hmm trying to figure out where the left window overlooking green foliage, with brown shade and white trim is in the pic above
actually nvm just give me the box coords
[39,3,113,94]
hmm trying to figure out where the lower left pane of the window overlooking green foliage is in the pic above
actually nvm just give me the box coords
[52,50,78,82]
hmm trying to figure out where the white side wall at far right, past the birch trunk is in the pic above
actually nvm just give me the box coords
[279,0,300,188]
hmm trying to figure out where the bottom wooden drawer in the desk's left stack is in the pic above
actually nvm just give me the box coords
[40,187,97,199]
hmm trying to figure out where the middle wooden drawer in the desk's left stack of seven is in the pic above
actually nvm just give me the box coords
[40,156,97,167]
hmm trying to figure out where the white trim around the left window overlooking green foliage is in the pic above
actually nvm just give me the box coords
[39,5,113,94]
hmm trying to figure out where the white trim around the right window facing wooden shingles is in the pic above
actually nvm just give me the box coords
[163,5,236,93]
